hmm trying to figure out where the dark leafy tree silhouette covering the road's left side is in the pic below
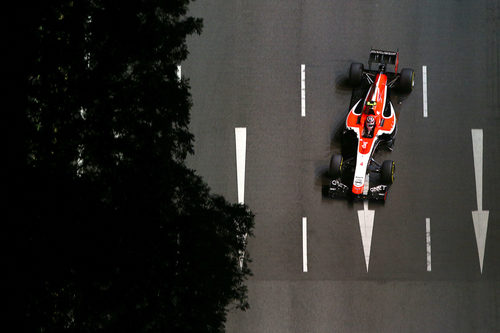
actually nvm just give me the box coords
[7,0,253,332]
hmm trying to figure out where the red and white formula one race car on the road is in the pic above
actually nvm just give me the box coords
[328,50,414,200]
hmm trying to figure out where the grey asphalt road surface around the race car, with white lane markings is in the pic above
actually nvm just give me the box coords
[182,0,500,333]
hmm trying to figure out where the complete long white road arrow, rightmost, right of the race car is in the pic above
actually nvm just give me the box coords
[471,129,489,274]
